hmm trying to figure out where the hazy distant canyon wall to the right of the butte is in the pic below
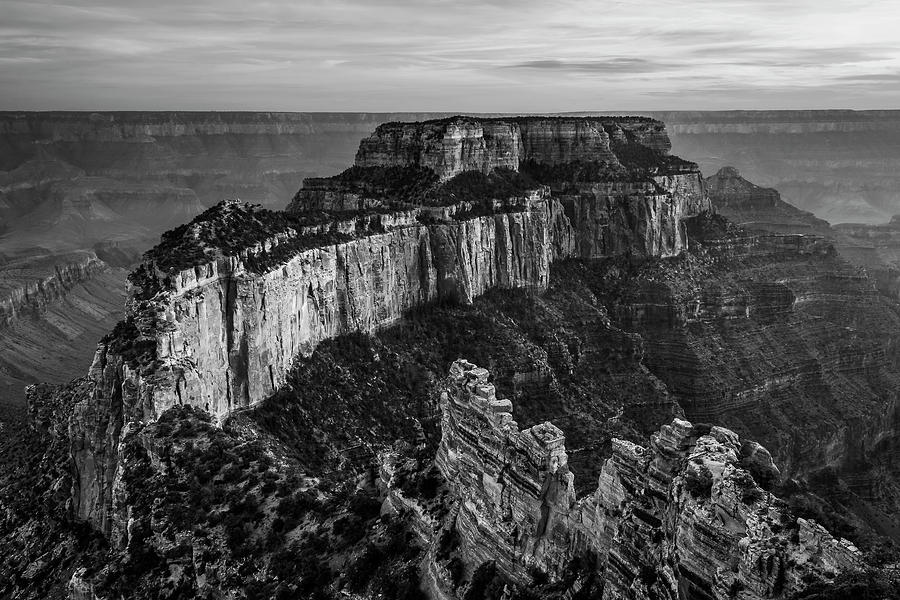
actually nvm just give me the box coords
[648,110,900,224]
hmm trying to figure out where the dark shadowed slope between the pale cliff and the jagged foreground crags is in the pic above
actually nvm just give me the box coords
[247,270,679,493]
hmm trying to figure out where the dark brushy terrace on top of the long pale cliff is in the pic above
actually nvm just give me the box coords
[129,167,542,299]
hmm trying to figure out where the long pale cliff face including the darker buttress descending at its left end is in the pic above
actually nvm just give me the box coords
[73,190,552,530]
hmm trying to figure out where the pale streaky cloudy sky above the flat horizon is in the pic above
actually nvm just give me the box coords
[0,0,900,112]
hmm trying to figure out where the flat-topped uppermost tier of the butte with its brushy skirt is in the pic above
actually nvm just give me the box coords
[289,116,697,218]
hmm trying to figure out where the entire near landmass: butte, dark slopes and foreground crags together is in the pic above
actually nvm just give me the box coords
[0,117,900,600]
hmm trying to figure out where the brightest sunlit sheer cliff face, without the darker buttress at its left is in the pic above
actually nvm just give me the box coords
[130,195,552,417]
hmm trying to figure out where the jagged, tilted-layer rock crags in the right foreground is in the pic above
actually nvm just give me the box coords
[437,360,860,600]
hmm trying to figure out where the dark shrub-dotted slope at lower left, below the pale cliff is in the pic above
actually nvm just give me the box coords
[86,408,421,600]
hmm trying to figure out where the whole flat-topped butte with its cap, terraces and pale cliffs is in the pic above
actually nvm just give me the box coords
[74,117,708,531]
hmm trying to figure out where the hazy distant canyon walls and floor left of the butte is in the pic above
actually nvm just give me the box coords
[0,112,450,406]
